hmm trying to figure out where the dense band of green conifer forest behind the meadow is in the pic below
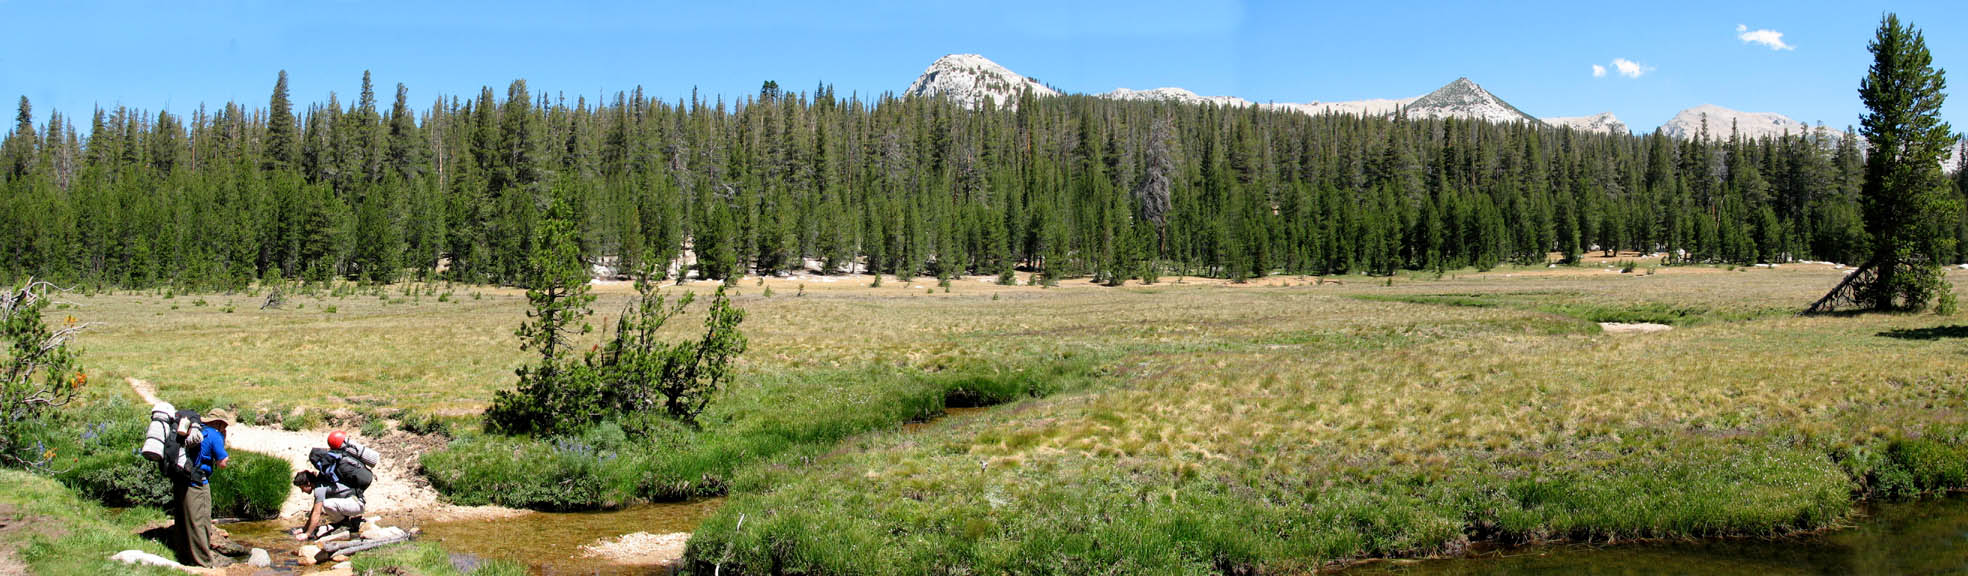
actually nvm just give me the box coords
[0,73,1968,289]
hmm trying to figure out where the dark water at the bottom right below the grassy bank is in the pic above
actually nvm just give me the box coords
[1342,497,1968,576]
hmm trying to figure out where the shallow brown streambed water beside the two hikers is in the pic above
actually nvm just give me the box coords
[224,499,722,574]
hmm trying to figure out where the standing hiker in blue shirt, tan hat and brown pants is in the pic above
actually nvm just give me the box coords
[165,413,232,568]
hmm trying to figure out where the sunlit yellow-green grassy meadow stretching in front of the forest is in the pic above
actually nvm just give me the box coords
[42,265,1968,574]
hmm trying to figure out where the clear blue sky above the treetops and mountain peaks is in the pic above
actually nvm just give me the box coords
[0,0,1968,130]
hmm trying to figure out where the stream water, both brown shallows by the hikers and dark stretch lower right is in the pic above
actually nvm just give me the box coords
[211,497,1968,576]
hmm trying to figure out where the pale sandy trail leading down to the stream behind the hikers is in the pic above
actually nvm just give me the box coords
[130,377,527,521]
